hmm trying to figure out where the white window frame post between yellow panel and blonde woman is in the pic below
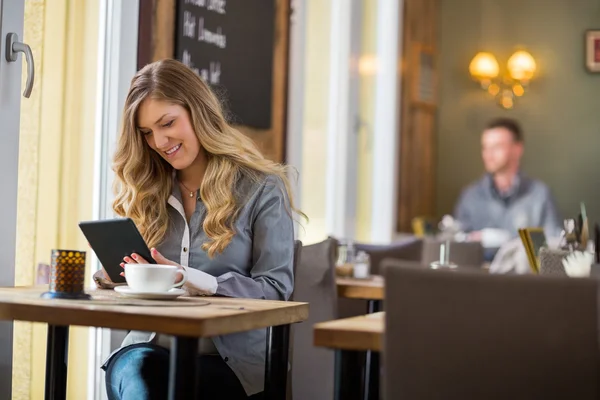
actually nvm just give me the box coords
[88,0,139,400]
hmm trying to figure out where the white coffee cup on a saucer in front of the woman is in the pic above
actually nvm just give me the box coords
[125,264,187,292]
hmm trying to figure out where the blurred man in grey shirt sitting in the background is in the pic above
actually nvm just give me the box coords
[454,118,562,259]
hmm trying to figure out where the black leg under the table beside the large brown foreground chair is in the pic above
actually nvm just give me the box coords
[334,350,364,400]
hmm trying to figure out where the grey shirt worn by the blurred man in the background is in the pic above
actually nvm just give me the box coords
[454,174,561,237]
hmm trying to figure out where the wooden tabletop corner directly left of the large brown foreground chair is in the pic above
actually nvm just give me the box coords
[314,311,385,351]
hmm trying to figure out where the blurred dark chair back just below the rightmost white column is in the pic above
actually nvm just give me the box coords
[355,237,423,275]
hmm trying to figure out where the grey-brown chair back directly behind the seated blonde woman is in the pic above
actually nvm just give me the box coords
[291,238,338,400]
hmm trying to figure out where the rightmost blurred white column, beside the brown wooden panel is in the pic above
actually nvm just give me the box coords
[371,0,403,243]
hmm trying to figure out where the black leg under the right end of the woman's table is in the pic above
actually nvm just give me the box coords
[264,325,290,400]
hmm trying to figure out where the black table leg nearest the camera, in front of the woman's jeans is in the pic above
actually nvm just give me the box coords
[169,336,198,400]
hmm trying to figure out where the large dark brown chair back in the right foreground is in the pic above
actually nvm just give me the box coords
[384,266,600,400]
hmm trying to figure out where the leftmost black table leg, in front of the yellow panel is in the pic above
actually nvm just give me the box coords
[44,325,69,400]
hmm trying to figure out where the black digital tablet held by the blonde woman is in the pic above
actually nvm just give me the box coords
[79,218,156,283]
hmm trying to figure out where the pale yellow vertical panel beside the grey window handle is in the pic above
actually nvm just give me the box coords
[13,0,99,399]
